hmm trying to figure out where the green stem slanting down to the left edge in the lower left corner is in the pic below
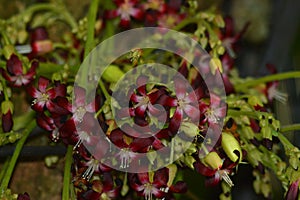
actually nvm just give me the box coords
[0,120,36,192]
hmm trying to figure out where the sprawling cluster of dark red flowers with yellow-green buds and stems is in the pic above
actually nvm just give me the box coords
[0,0,300,200]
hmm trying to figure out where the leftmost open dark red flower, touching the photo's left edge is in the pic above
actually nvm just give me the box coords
[0,54,38,87]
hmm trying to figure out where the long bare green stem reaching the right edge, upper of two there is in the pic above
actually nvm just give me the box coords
[234,71,300,91]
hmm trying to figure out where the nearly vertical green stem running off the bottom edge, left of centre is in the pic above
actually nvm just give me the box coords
[62,145,73,200]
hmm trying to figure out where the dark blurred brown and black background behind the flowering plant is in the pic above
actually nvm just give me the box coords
[0,0,300,200]
